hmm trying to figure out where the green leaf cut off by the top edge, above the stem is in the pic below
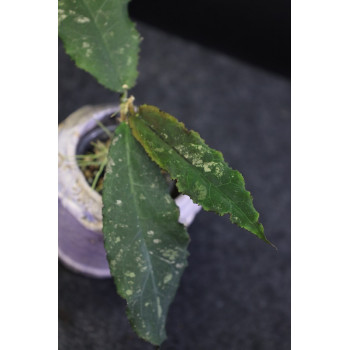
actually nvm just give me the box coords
[58,0,140,92]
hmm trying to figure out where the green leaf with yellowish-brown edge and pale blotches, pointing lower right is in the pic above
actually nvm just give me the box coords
[129,105,270,243]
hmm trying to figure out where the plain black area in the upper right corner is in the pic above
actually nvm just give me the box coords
[129,0,291,77]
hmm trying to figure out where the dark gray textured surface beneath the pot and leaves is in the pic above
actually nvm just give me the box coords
[58,24,290,350]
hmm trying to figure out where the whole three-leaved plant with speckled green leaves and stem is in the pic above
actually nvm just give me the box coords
[58,0,270,346]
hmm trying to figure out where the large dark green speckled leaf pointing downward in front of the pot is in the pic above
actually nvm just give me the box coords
[103,123,189,345]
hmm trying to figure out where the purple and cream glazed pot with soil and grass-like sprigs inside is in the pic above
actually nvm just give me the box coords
[58,104,201,278]
